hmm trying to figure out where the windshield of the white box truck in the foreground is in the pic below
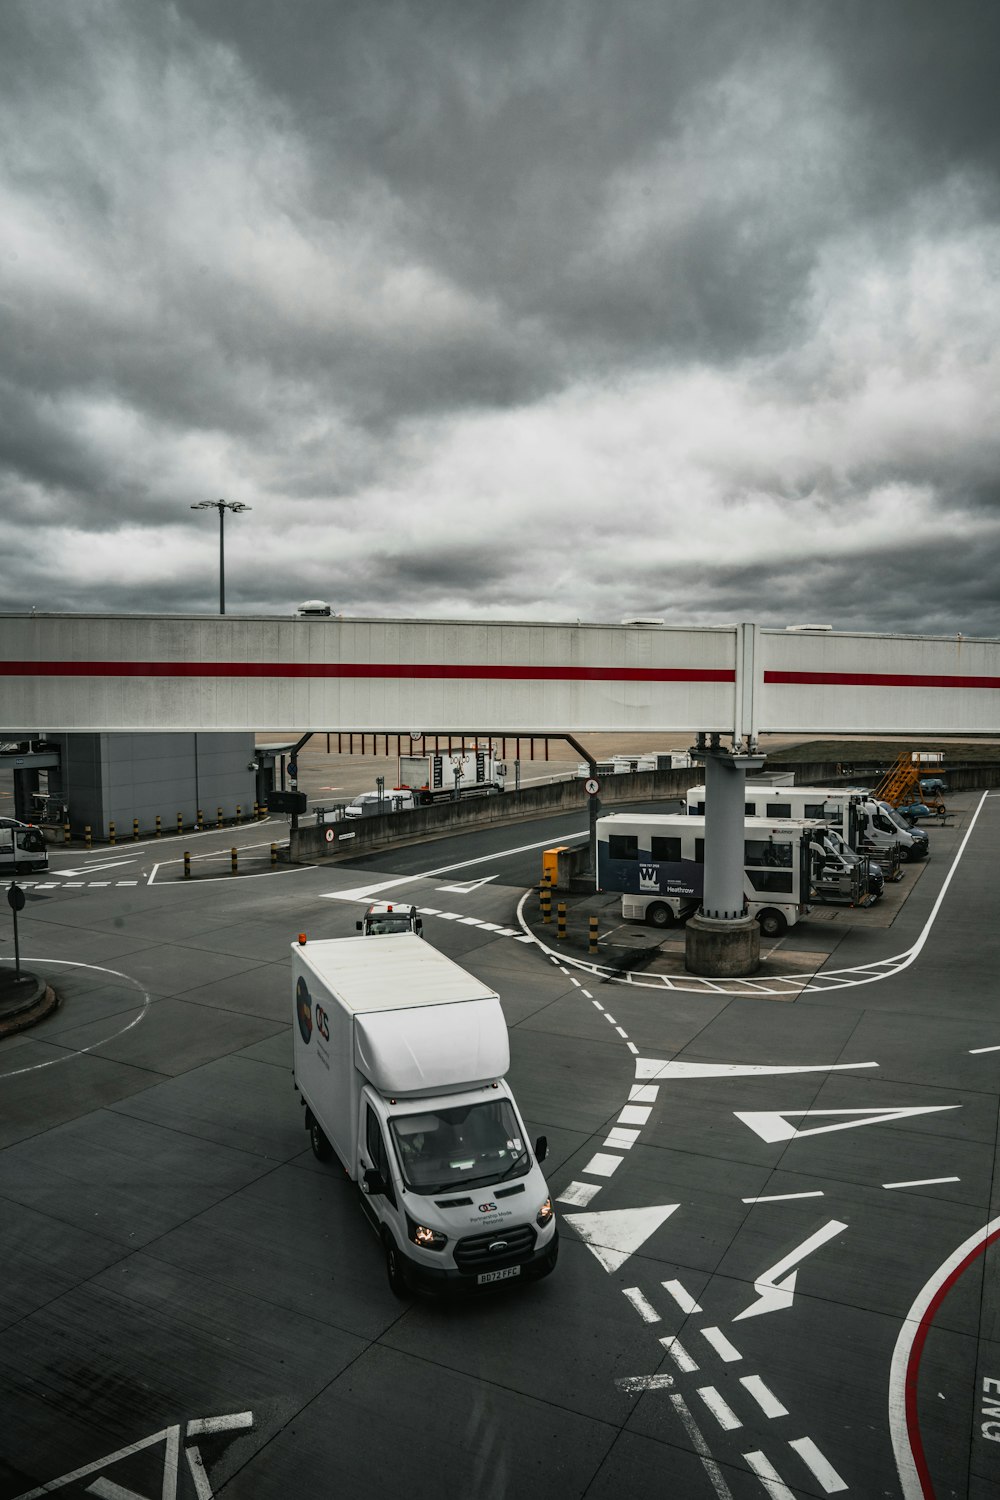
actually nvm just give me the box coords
[390,1098,531,1193]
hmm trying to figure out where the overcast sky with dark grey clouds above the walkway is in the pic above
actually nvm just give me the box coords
[0,0,1000,636]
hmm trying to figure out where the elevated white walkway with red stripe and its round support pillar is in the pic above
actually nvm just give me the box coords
[0,614,1000,974]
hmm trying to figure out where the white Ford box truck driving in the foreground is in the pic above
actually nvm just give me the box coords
[292,933,559,1298]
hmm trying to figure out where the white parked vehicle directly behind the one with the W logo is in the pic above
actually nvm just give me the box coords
[685,782,928,864]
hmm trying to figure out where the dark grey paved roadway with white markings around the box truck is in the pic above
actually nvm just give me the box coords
[0,795,1000,1500]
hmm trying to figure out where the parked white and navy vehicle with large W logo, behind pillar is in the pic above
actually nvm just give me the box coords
[597,813,874,938]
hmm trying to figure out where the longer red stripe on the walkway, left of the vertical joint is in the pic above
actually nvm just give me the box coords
[0,662,736,683]
